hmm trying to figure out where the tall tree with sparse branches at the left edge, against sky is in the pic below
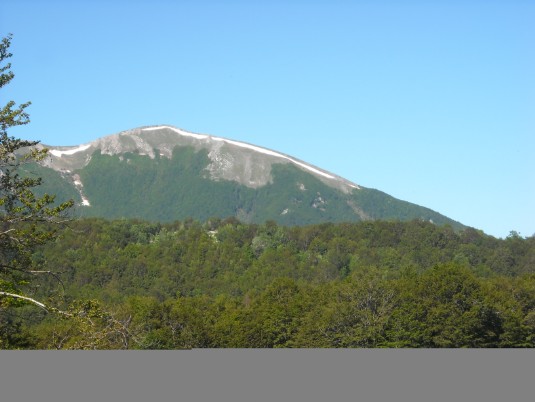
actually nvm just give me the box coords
[0,35,73,324]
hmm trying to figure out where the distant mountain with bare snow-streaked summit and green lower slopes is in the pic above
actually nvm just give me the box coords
[28,126,463,229]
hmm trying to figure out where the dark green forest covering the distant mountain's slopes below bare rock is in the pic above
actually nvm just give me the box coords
[25,146,464,229]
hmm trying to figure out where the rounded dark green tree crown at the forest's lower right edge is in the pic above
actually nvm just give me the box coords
[387,263,503,348]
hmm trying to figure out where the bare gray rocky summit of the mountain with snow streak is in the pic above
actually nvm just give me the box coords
[46,126,359,193]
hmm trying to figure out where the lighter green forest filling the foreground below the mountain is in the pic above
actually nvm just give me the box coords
[0,218,535,349]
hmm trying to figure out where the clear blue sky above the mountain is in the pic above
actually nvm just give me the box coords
[0,0,535,237]
